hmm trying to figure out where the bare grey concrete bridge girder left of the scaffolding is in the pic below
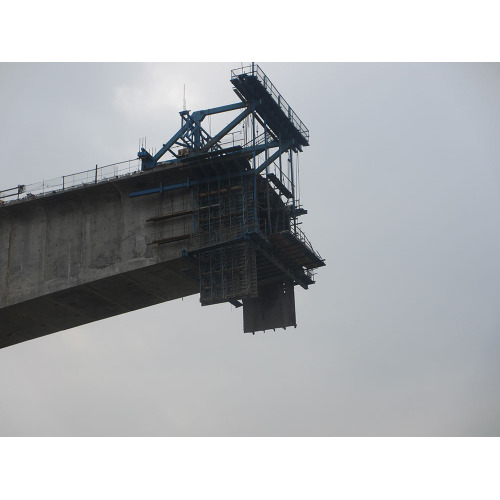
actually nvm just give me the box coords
[0,164,199,347]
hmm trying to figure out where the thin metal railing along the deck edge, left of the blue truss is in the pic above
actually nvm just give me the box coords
[0,159,141,204]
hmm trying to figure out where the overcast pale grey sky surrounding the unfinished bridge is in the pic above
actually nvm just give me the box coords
[0,63,500,436]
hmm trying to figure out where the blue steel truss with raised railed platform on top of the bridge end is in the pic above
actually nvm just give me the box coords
[137,63,309,232]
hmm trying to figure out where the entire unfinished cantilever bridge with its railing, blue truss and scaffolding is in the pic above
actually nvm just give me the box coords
[0,64,325,348]
